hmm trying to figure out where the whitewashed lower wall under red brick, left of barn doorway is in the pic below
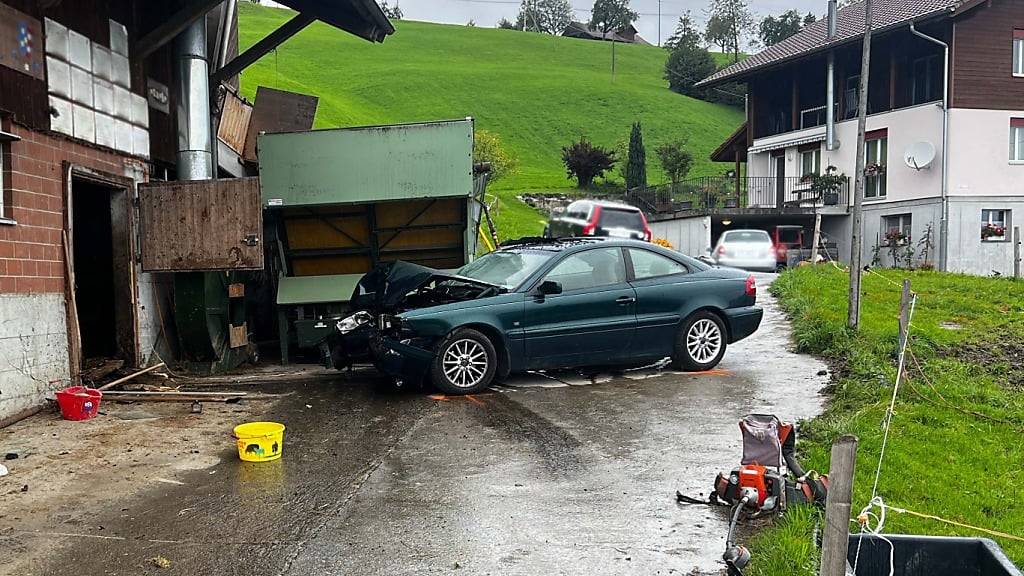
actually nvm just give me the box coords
[0,294,70,420]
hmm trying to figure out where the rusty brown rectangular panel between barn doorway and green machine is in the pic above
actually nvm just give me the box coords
[138,178,263,272]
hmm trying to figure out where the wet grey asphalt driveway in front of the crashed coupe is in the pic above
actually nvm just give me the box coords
[14,276,826,576]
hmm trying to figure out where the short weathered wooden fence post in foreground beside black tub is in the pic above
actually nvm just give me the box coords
[821,436,857,576]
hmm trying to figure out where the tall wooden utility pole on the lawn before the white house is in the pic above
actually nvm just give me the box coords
[846,0,871,330]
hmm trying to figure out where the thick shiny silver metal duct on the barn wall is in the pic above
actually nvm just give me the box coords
[174,18,214,180]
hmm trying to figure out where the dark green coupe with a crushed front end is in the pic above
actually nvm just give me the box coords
[332,239,762,394]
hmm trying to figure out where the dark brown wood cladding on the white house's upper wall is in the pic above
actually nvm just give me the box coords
[951,0,1024,110]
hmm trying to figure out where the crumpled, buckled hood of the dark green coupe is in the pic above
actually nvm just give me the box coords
[350,260,504,312]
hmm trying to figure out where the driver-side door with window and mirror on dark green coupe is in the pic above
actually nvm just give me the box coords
[524,247,636,369]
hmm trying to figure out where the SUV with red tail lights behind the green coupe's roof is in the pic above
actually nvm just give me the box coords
[545,200,650,242]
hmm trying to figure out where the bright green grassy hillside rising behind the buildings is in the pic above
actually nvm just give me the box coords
[240,2,742,196]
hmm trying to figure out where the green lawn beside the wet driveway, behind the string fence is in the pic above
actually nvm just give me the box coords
[749,266,1024,576]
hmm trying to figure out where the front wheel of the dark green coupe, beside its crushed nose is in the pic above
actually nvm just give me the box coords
[430,328,498,395]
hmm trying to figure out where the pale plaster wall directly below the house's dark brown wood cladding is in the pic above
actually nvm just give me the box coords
[949,109,1024,197]
